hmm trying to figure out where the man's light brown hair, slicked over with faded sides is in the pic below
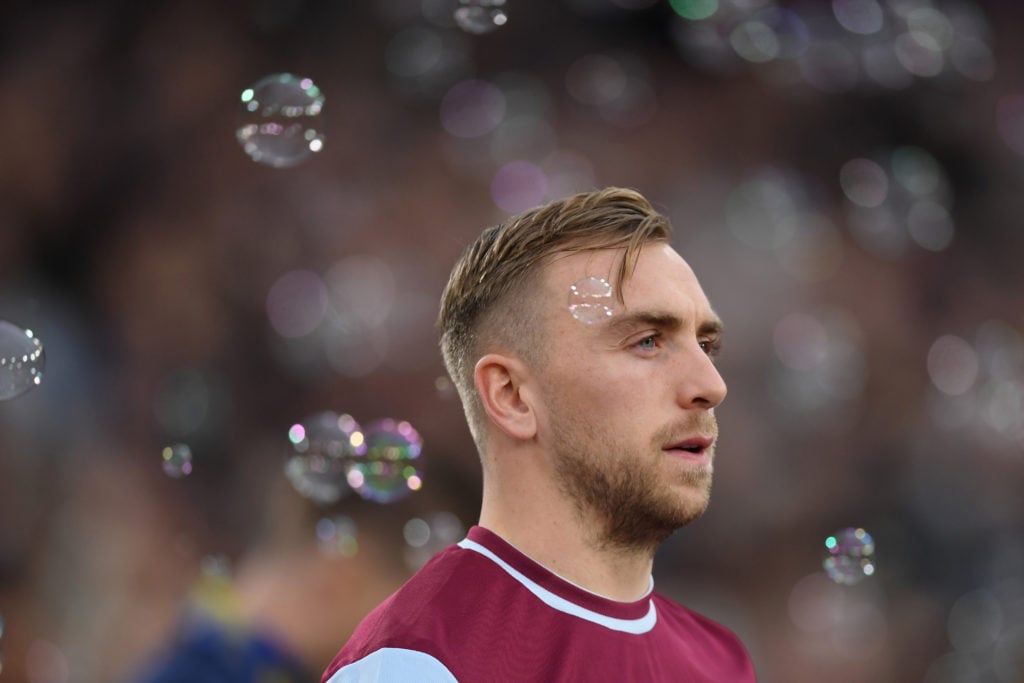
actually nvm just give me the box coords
[437,187,672,448]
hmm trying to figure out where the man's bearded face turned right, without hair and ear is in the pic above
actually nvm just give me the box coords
[539,243,726,550]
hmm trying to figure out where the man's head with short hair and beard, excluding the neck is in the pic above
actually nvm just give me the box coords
[440,188,725,549]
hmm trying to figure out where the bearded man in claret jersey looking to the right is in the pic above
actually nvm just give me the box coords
[323,187,754,683]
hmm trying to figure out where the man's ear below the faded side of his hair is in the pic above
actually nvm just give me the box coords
[473,353,537,440]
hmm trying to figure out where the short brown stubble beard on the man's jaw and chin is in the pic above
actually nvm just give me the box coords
[553,409,712,556]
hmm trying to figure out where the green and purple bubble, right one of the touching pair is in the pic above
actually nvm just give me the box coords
[346,419,423,503]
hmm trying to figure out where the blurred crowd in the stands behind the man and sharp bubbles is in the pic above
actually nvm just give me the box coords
[0,0,1024,683]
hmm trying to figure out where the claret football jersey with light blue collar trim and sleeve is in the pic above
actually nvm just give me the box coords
[322,526,755,683]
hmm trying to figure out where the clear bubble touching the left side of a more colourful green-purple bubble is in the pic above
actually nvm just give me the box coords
[285,411,367,504]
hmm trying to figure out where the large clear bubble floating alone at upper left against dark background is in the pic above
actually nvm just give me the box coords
[236,74,325,168]
